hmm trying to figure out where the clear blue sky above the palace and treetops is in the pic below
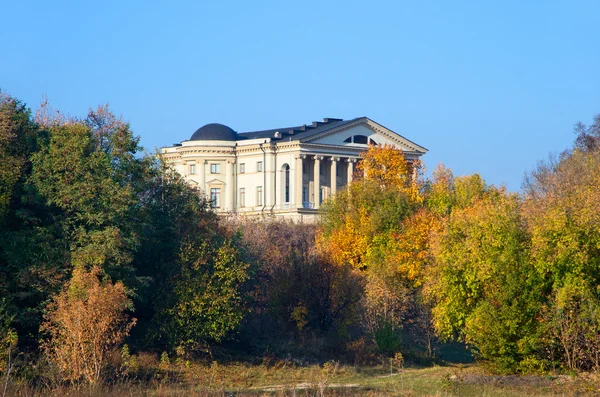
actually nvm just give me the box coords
[0,0,600,191]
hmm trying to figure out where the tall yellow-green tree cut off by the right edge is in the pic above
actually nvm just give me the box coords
[524,116,600,369]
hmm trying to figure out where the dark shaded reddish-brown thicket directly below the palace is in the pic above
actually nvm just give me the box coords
[238,221,363,352]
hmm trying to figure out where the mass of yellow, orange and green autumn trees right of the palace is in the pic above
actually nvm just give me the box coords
[318,128,600,372]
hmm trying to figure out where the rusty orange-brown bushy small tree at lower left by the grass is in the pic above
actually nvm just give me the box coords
[41,266,135,384]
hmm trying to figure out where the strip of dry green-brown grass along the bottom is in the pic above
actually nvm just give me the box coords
[7,361,600,397]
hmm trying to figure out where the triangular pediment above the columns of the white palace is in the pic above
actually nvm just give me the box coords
[301,117,427,154]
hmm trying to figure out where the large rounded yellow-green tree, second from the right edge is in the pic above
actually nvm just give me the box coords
[429,189,542,370]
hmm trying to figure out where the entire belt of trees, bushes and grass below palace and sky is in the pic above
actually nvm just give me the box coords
[0,91,600,395]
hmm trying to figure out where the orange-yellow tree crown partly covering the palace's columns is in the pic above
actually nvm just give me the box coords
[317,145,422,268]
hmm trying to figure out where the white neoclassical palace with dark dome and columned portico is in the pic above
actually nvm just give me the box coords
[161,117,427,221]
